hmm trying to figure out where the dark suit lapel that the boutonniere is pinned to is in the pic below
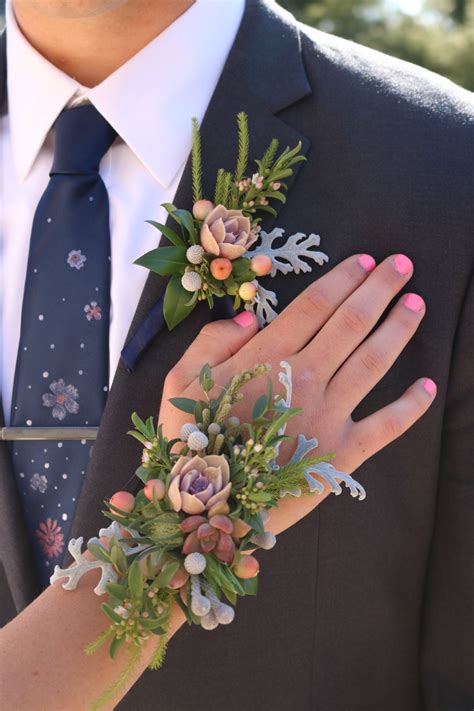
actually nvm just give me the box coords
[0,0,310,606]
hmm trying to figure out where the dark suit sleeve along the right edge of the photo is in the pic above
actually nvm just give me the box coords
[421,281,474,711]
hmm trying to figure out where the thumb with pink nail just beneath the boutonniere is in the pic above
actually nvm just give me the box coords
[173,311,258,389]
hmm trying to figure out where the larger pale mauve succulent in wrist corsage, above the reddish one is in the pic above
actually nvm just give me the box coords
[168,454,232,514]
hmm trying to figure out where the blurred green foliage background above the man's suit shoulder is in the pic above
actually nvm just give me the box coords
[0,0,474,91]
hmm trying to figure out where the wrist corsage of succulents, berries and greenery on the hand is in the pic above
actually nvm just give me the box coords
[51,362,365,708]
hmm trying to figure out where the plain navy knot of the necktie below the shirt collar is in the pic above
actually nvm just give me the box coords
[50,104,117,175]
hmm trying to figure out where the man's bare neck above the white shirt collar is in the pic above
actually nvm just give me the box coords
[12,0,194,87]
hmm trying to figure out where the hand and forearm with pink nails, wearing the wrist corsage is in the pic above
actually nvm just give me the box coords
[0,256,435,711]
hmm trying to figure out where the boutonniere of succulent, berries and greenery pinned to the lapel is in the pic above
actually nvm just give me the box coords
[135,112,328,330]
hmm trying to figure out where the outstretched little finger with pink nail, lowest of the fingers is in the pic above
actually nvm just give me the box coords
[350,378,436,467]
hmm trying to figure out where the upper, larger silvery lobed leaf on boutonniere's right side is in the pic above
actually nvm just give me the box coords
[247,227,329,277]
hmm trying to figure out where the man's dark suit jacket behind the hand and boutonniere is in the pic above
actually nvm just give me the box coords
[0,0,474,711]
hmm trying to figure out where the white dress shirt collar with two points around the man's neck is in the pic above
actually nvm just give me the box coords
[6,0,245,188]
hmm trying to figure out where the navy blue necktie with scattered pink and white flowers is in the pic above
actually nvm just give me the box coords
[11,104,117,589]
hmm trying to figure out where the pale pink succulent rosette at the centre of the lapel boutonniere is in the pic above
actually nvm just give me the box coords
[200,205,257,260]
